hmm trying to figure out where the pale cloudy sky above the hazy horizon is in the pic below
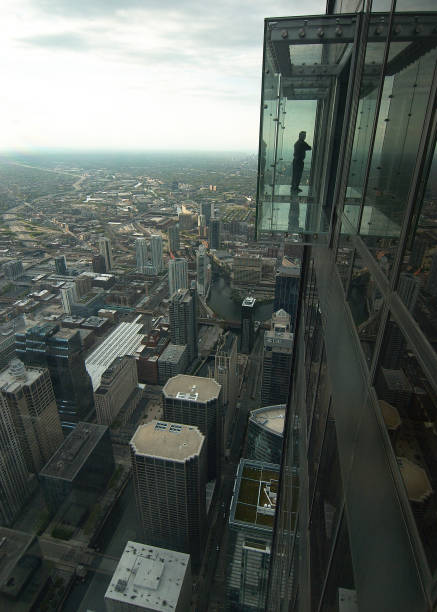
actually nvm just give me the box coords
[0,0,325,151]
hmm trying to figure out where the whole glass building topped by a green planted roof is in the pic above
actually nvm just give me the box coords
[226,459,279,612]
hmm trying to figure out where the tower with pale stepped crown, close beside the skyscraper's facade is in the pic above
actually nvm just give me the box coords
[261,309,293,406]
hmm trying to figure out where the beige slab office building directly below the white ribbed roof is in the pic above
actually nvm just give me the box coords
[94,355,141,425]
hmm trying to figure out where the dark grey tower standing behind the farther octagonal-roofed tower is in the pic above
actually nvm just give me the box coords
[169,289,198,363]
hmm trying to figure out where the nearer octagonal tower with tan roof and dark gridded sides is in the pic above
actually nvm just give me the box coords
[130,420,206,565]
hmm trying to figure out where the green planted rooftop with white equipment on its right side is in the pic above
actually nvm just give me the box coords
[229,459,279,531]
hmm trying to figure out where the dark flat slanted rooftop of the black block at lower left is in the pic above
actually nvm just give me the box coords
[40,422,108,481]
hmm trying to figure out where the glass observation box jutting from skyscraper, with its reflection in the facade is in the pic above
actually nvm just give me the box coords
[257,12,437,244]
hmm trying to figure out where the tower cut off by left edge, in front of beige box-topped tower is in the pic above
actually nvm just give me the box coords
[0,396,30,527]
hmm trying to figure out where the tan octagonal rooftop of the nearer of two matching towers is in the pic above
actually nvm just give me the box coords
[130,420,205,461]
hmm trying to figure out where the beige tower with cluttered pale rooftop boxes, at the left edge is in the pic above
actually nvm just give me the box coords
[0,359,64,473]
